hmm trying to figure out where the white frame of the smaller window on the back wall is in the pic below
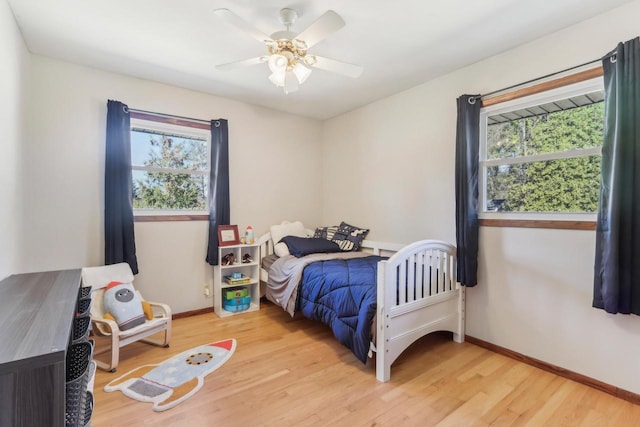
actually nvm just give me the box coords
[130,118,211,216]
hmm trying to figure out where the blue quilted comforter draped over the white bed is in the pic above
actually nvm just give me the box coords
[298,256,385,363]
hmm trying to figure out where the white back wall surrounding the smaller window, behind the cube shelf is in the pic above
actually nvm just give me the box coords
[18,55,321,313]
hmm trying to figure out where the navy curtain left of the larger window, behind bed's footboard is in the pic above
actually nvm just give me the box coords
[456,95,481,286]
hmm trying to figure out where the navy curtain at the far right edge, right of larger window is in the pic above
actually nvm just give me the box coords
[593,37,640,315]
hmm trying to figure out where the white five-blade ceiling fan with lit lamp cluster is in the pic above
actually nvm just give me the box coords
[214,8,363,94]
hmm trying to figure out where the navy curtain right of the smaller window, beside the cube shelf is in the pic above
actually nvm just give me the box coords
[207,119,231,265]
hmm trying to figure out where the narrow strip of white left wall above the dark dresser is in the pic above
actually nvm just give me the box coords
[0,0,29,280]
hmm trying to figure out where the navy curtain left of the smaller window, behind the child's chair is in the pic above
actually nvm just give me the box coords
[104,100,138,274]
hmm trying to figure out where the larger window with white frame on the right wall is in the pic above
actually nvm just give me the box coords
[479,78,604,219]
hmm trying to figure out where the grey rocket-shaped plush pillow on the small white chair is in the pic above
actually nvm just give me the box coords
[102,282,145,331]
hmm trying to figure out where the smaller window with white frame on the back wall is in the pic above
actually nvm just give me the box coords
[131,116,211,215]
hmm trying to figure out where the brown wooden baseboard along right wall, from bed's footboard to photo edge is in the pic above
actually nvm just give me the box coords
[465,335,640,405]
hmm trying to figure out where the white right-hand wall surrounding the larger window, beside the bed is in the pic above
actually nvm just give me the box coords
[322,1,640,393]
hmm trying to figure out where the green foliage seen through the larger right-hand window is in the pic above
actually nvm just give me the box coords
[486,103,604,212]
